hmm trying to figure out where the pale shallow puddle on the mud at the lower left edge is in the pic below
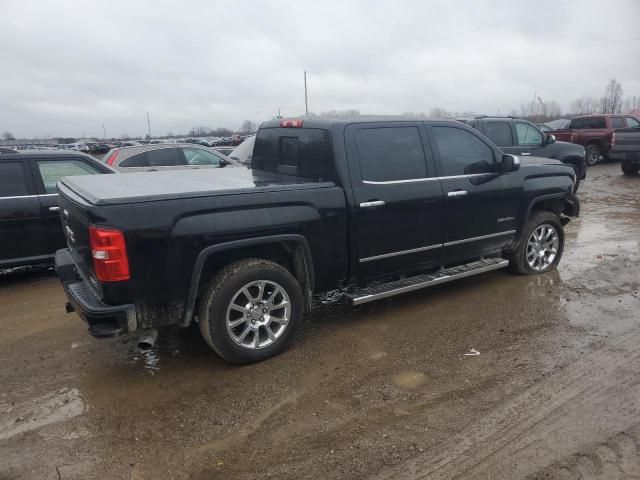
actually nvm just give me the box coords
[0,388,85,440]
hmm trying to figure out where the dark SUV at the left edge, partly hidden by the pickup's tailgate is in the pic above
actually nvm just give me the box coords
[0,151,114,268]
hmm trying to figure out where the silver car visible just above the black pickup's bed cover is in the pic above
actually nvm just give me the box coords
[103,143,239,172]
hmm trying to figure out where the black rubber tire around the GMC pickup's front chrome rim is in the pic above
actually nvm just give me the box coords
[508,211,564,275]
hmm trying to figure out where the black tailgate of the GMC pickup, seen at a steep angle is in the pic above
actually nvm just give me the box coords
[58,183,98,288]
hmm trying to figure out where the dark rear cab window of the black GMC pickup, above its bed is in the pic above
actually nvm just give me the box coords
[251,128,336,181]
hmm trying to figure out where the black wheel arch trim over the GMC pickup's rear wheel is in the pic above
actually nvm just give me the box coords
[182,234,315,327]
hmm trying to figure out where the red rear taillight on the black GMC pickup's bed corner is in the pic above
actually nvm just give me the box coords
[89,227,131,282]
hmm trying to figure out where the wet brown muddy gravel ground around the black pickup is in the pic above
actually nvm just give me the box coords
[0,164,640,480]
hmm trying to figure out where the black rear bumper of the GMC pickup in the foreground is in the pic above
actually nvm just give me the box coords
[55,249,137,338]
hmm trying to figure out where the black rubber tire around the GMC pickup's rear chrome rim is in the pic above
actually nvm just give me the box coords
[198,258,304,364]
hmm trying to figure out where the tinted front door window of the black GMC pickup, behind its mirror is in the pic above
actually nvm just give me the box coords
[431,127,494,177]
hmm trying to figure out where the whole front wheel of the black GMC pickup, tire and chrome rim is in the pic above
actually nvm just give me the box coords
[509,212,564,275]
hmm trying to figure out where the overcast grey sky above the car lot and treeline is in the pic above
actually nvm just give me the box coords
[0,0,640,137]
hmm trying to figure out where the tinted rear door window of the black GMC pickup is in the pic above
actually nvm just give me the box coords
[355,127,428,182]
